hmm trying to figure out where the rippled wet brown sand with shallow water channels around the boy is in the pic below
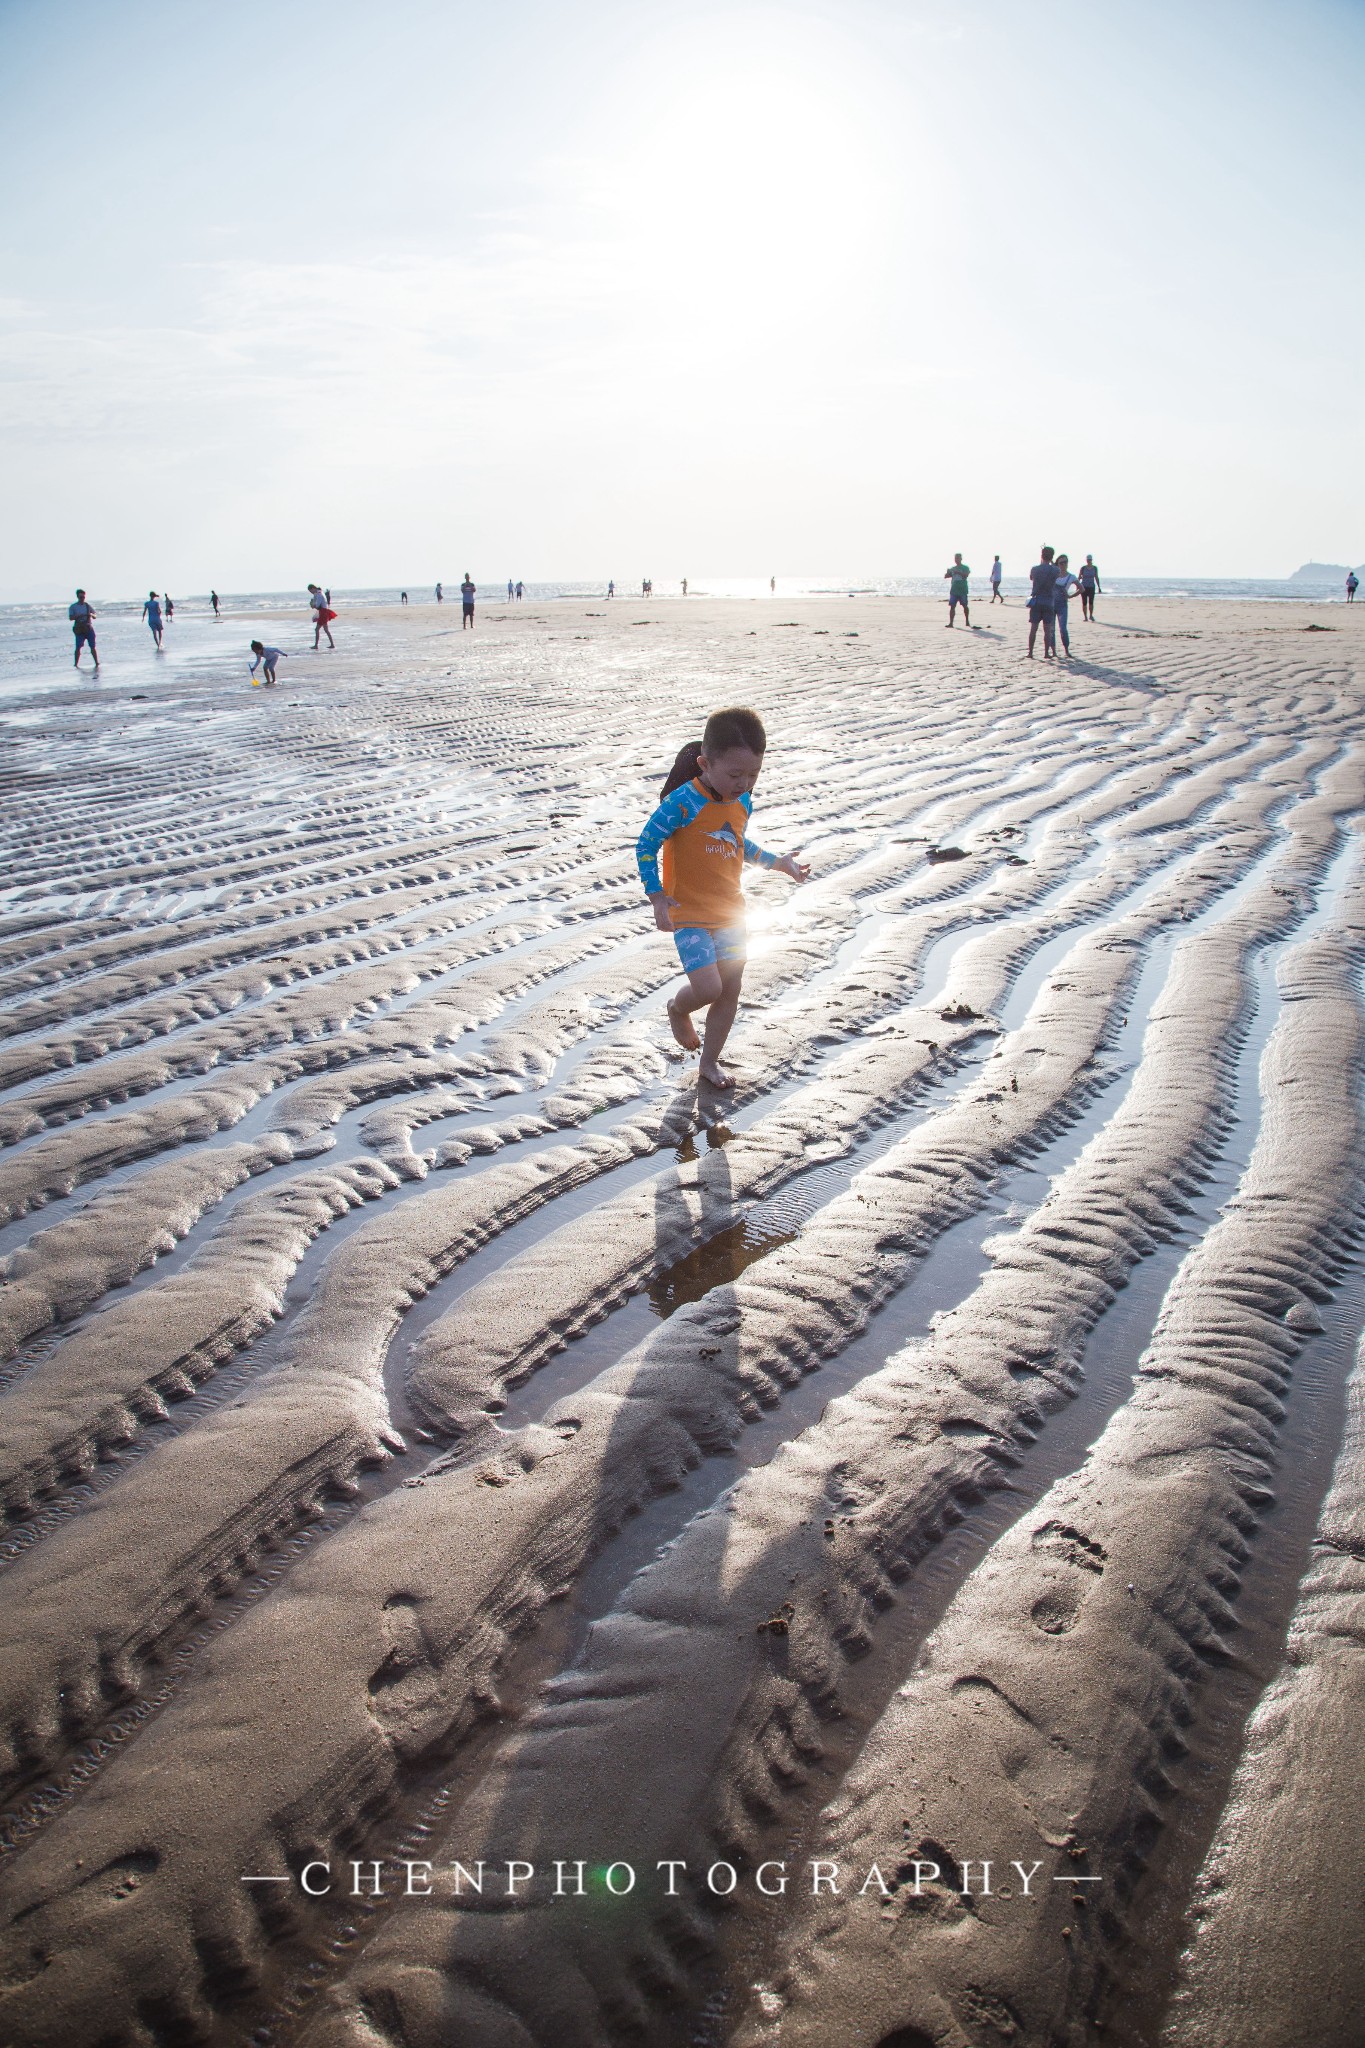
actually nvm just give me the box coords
[0,598,1365,2048]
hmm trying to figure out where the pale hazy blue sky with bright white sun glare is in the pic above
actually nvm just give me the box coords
[0,0,1365,598]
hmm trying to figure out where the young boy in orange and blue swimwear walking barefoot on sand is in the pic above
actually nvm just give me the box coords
[634,705,810,1087]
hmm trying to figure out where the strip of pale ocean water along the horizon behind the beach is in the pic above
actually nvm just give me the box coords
[0,567,1345,696]
